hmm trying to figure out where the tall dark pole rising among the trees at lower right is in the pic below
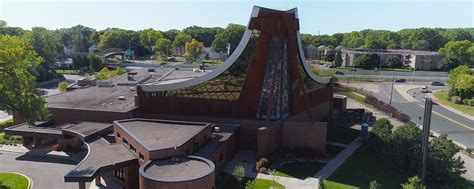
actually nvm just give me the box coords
[419,98,433,185]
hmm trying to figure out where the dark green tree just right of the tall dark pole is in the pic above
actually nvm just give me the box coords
[426,134,466,185]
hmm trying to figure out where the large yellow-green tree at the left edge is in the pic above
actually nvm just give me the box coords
[0,36,48,124]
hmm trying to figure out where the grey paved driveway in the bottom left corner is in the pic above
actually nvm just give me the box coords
[0,151,89,189]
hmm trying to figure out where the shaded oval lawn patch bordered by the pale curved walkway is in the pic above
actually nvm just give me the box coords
[275,162,325,179]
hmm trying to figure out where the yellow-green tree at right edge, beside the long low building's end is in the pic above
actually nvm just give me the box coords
[439,40,474,66]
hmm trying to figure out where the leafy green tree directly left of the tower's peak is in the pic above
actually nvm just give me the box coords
[212,24,246,54]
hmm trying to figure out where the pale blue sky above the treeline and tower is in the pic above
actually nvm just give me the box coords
[0,0,474,35]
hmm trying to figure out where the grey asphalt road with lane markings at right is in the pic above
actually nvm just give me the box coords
[374,83,474,148]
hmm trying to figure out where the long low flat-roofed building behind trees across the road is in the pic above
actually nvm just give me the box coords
[341,48,442,70]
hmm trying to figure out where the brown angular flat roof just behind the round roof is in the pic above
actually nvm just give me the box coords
[115,119,210,151]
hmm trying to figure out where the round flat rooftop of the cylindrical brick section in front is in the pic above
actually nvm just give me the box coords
[142,156,214,182]
